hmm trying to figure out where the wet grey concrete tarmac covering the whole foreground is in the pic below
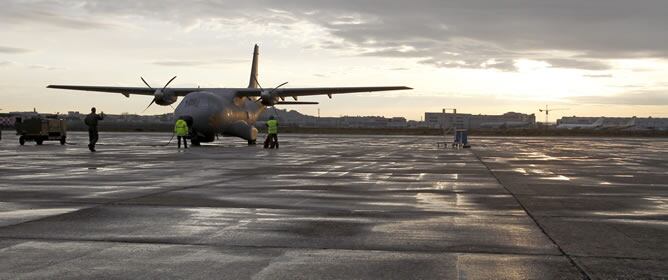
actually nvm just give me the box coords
[0,131,668,279]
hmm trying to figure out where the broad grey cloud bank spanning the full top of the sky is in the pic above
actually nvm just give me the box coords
[5,0,668,71]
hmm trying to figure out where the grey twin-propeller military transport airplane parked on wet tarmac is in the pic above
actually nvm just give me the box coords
[47,45,412,146]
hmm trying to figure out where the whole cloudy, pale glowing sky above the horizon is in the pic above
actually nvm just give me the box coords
[0,0,668,121]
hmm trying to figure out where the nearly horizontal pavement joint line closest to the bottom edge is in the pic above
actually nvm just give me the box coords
[0,236,565,257]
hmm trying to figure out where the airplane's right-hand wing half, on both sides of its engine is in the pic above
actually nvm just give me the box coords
[237,86,412,97]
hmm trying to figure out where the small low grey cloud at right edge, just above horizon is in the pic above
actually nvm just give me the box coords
[570,90,668,106]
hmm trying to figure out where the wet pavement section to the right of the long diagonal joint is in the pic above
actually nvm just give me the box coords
[475,138,668,278]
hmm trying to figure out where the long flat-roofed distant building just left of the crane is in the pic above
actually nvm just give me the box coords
[424,112,536,129]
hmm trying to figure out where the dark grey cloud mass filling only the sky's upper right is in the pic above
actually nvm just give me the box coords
[272,0,668,71]
